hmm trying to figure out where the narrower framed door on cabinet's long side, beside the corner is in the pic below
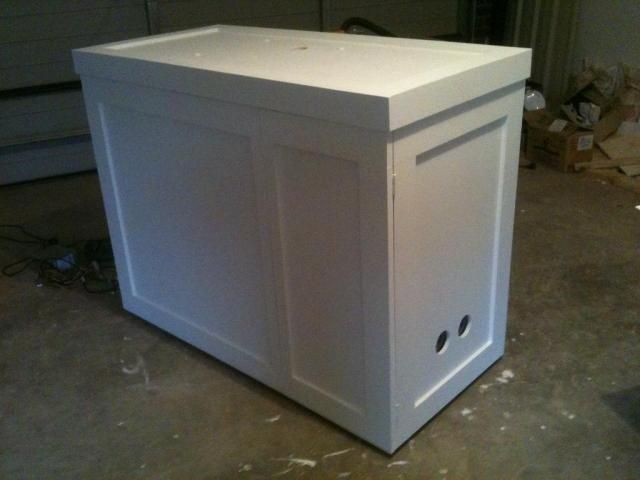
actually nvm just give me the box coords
[261,112,390,448]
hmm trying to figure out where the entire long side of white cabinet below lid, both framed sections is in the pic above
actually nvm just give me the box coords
[85,79,398,449]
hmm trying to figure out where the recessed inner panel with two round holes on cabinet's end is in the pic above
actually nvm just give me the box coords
[398,120,504,407]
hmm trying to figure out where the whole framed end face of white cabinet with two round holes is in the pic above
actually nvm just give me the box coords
[394,84,519,444]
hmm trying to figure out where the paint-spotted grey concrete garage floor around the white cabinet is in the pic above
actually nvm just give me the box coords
[0,168,640,480]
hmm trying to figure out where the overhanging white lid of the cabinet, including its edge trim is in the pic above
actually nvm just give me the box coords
[74,26,530,131]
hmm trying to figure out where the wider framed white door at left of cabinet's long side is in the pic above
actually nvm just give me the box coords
[85,79,280,387]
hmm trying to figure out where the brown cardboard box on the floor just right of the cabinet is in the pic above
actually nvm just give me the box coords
[524,110,594,172]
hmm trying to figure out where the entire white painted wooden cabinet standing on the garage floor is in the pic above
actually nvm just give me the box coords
[74,26,531,452]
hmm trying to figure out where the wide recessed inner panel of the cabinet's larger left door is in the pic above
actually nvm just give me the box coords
[103,107,271,362]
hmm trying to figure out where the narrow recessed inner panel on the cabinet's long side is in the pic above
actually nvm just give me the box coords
[275,147,364,410]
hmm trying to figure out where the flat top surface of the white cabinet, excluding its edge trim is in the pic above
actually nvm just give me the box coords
[74,25,527,98]
